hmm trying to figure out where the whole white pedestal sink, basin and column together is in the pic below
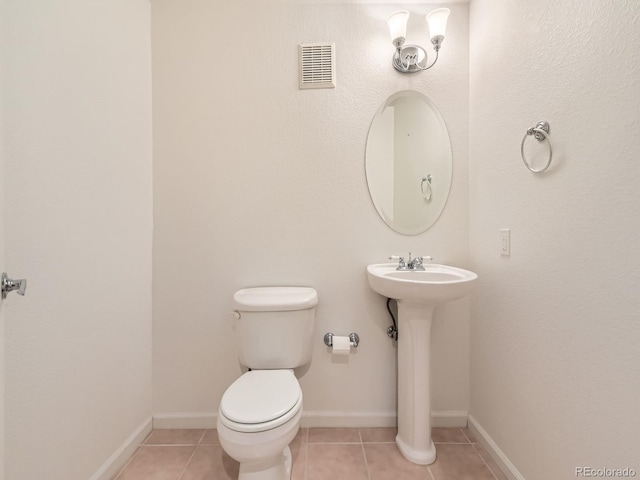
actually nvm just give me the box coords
[367,263,478,465]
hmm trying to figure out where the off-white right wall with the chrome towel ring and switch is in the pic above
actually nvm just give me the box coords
[470,0,640,480]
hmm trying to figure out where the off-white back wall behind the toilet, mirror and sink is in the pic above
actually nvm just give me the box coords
[152,0,469,424]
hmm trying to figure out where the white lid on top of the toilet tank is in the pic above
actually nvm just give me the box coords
[233,287,318,312]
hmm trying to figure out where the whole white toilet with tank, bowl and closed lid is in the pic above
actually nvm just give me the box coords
[217,287,318,480]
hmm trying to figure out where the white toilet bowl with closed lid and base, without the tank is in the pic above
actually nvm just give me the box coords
[217,370,302,480]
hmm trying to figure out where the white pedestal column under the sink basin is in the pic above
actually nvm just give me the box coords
[396,300,436,465]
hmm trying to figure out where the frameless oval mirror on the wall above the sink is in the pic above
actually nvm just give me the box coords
[365,90,453,235]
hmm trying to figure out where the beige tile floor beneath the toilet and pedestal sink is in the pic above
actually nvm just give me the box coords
[113,428,506,480]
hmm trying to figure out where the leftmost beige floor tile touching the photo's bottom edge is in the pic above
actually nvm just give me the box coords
[116,446,195,480]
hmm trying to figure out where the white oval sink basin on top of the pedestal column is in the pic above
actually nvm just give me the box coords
[367,263,478,306]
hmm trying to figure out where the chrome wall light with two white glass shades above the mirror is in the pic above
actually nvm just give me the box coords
[387,8,450,73]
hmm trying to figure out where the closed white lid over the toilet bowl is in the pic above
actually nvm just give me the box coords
[220,370,302,424]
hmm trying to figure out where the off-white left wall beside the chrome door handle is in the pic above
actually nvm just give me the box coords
[1,0,152,480]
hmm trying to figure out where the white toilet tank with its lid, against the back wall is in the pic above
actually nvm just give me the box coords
[233,287,318,370]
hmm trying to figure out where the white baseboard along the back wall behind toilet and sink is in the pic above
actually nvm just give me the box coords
[153,411,468,428]
